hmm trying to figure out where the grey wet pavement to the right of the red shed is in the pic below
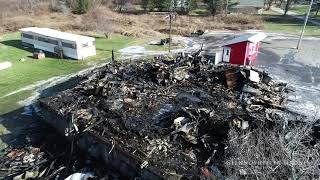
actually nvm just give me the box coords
[257,34,320,118]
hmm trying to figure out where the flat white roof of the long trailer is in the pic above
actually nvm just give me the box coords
[20,27,95,43]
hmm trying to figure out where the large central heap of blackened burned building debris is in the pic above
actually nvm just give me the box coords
[41,56,287,179]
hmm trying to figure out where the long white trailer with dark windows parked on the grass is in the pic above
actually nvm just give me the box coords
[20,27,96,60]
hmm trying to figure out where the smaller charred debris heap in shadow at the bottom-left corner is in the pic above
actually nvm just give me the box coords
[0,122,114,180]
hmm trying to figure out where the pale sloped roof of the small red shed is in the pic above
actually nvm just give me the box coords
[223,32,267,46]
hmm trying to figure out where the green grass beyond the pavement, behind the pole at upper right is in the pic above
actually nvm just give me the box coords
[261,11,320,37]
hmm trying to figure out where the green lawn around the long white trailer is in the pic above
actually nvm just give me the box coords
[0,33,148,114]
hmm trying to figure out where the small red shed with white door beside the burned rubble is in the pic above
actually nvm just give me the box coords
[223,33,267,65]
